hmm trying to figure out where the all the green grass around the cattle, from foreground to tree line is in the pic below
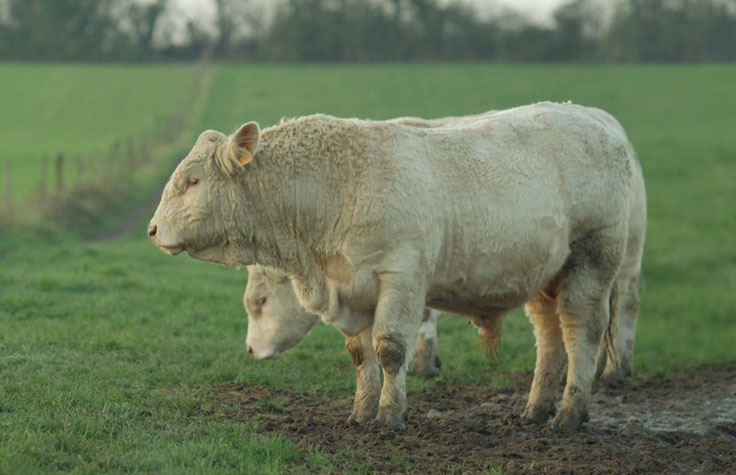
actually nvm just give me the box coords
[0,65,736,473]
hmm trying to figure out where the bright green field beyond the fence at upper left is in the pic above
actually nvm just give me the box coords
[0,64,201,202]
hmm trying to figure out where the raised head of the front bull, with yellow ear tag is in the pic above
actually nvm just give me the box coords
[148,122,260,265]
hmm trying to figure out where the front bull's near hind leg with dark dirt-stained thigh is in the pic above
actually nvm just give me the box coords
[553,229,625,430]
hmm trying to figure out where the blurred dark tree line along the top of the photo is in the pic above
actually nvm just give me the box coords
[0,0,736,62]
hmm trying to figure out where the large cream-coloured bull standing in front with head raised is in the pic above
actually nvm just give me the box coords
[149,103,640,429]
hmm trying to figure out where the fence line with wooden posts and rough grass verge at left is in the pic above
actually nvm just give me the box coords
[0,61,215,234]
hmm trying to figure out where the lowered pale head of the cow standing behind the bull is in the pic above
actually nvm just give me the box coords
[243,265,319,360]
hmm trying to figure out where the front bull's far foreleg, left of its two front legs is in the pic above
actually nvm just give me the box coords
[345,326,381,425]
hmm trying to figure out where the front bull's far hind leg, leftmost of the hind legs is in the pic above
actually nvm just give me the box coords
[523,294,565,424]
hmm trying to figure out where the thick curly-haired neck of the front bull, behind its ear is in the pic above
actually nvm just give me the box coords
[237,122,349,277]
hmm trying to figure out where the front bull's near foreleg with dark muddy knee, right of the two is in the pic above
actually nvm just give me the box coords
[373,273,425,429]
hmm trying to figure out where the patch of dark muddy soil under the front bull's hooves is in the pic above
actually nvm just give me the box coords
[214,370,736,473]
